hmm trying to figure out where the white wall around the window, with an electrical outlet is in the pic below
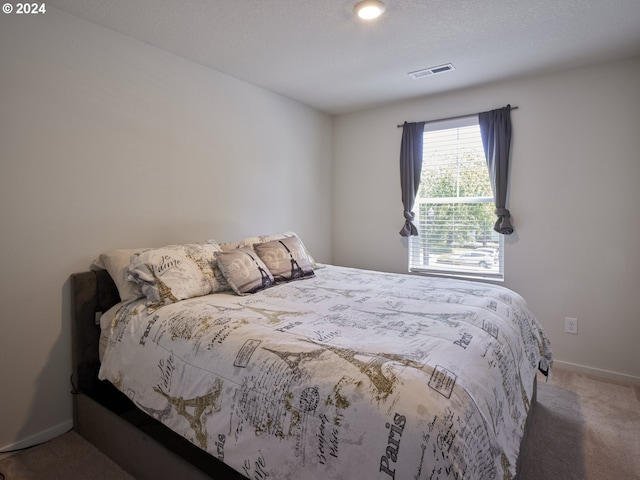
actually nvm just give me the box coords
[333,58,640,381]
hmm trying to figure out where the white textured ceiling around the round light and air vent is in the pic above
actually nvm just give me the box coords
[47,0,640,114]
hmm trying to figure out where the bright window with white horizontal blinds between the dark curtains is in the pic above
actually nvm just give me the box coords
[409,117,504,280]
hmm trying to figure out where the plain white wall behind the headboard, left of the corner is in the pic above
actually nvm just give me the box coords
[0,6,332,450]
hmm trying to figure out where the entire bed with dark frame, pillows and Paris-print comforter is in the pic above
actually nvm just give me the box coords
[71,232,552,480]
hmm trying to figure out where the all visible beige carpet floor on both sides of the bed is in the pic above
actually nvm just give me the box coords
[0,368,640,480]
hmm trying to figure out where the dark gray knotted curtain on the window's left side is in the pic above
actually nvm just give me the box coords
[400,122,425,237]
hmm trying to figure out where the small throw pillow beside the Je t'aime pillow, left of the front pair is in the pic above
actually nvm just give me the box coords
[216,247,275,295]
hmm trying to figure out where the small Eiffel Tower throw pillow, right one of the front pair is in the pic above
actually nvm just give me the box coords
[253,237,315,282]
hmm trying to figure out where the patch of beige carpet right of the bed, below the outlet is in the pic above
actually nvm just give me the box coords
[519,368,640,480]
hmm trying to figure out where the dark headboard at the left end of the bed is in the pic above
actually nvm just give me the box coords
[71,270,120,393]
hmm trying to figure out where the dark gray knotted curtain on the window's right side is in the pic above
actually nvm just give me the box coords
[478,105,513,235]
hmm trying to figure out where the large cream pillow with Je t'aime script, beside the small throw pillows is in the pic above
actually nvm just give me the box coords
[127,243,225,311]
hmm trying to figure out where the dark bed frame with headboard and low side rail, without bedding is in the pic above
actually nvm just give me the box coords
[71,270,536,480]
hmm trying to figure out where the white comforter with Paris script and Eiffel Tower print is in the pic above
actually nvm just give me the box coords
[100,265,551,480]
